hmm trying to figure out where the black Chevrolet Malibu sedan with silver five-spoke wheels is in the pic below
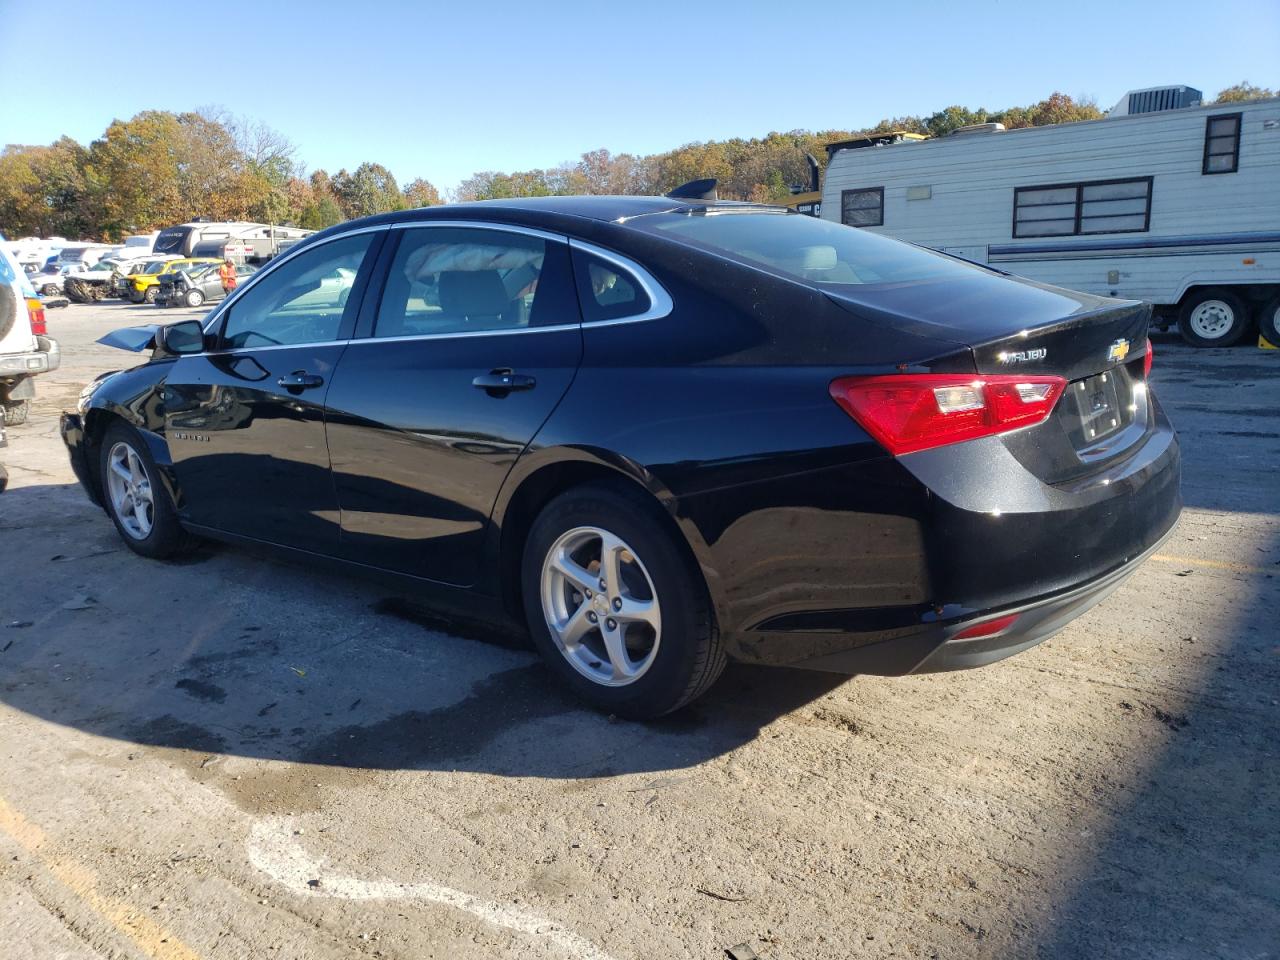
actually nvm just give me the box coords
[63,197,1181,717]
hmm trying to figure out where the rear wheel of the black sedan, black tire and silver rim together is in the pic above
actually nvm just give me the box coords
[521,484,727,719]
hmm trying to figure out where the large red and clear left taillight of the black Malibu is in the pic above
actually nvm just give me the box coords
[831,374,1066,456]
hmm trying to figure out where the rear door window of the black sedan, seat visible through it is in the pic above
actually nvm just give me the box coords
[374,227,579,338]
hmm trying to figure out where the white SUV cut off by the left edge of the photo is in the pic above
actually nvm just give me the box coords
[0,236,61,425]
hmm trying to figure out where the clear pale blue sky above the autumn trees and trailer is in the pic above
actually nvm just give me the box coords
[0,0,1280,189]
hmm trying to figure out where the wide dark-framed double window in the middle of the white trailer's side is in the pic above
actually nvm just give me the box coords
[1014,177,1152,237]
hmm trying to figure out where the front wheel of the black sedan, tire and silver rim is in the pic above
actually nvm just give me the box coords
[99,421,196,559]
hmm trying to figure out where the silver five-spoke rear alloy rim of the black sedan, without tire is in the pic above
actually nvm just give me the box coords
[541,526,662,687]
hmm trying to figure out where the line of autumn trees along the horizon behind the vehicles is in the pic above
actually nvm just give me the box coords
[0,82,1276,241]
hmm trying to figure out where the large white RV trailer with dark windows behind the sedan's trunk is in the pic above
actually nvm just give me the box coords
[822,87,1280,346]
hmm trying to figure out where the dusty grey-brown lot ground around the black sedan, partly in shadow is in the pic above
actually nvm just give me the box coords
[0,303,1280,960]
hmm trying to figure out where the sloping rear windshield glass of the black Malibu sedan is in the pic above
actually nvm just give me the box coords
[630,209,975,285]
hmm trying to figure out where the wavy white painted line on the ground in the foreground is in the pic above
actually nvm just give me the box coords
[248,817,613,960]
